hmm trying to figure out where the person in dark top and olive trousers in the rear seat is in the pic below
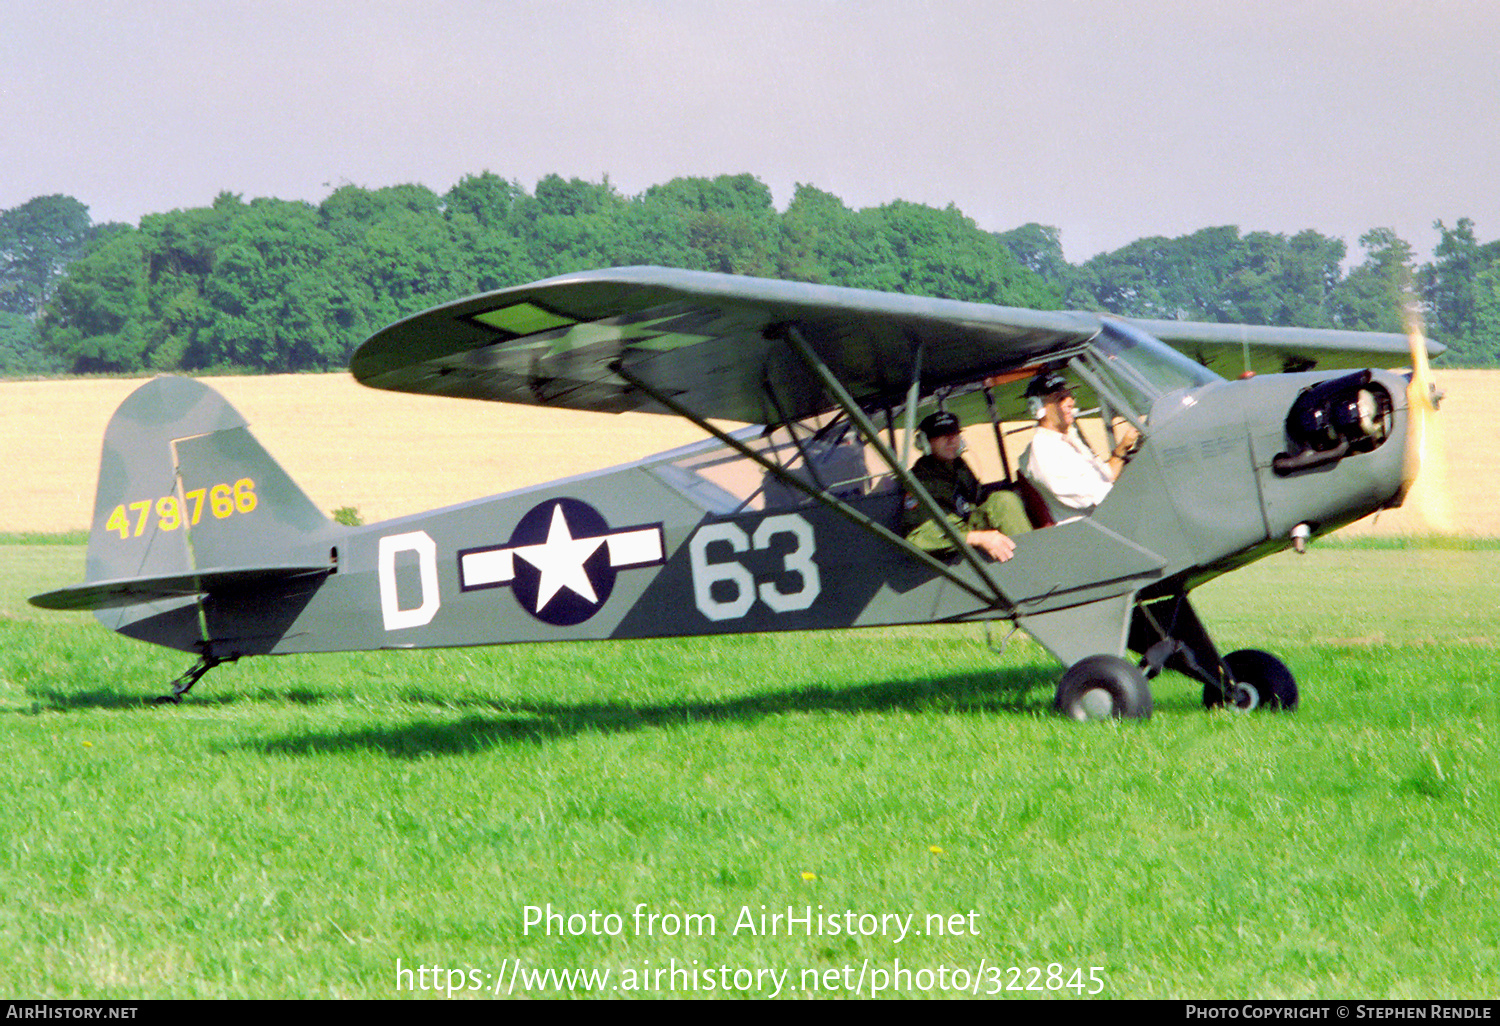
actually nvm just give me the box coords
[902,411,1031,563]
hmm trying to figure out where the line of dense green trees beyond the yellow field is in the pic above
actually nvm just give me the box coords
[0,173,1500,375]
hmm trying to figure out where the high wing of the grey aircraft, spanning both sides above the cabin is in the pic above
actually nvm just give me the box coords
[350,267,1442,425]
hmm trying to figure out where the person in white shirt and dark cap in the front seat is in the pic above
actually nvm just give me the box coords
[1020,371,1139,524]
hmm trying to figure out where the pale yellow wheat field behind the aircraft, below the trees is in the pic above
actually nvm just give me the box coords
[0,371,1500,537]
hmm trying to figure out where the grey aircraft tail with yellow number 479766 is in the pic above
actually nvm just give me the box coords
[38,377,339,651]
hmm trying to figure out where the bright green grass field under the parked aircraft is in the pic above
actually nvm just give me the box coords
[0,537,1500,999]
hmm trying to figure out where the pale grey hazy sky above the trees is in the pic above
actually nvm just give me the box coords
[0,0,1500,261]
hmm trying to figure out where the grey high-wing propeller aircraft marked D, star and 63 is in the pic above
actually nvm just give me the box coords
[32,267,1442,719]
